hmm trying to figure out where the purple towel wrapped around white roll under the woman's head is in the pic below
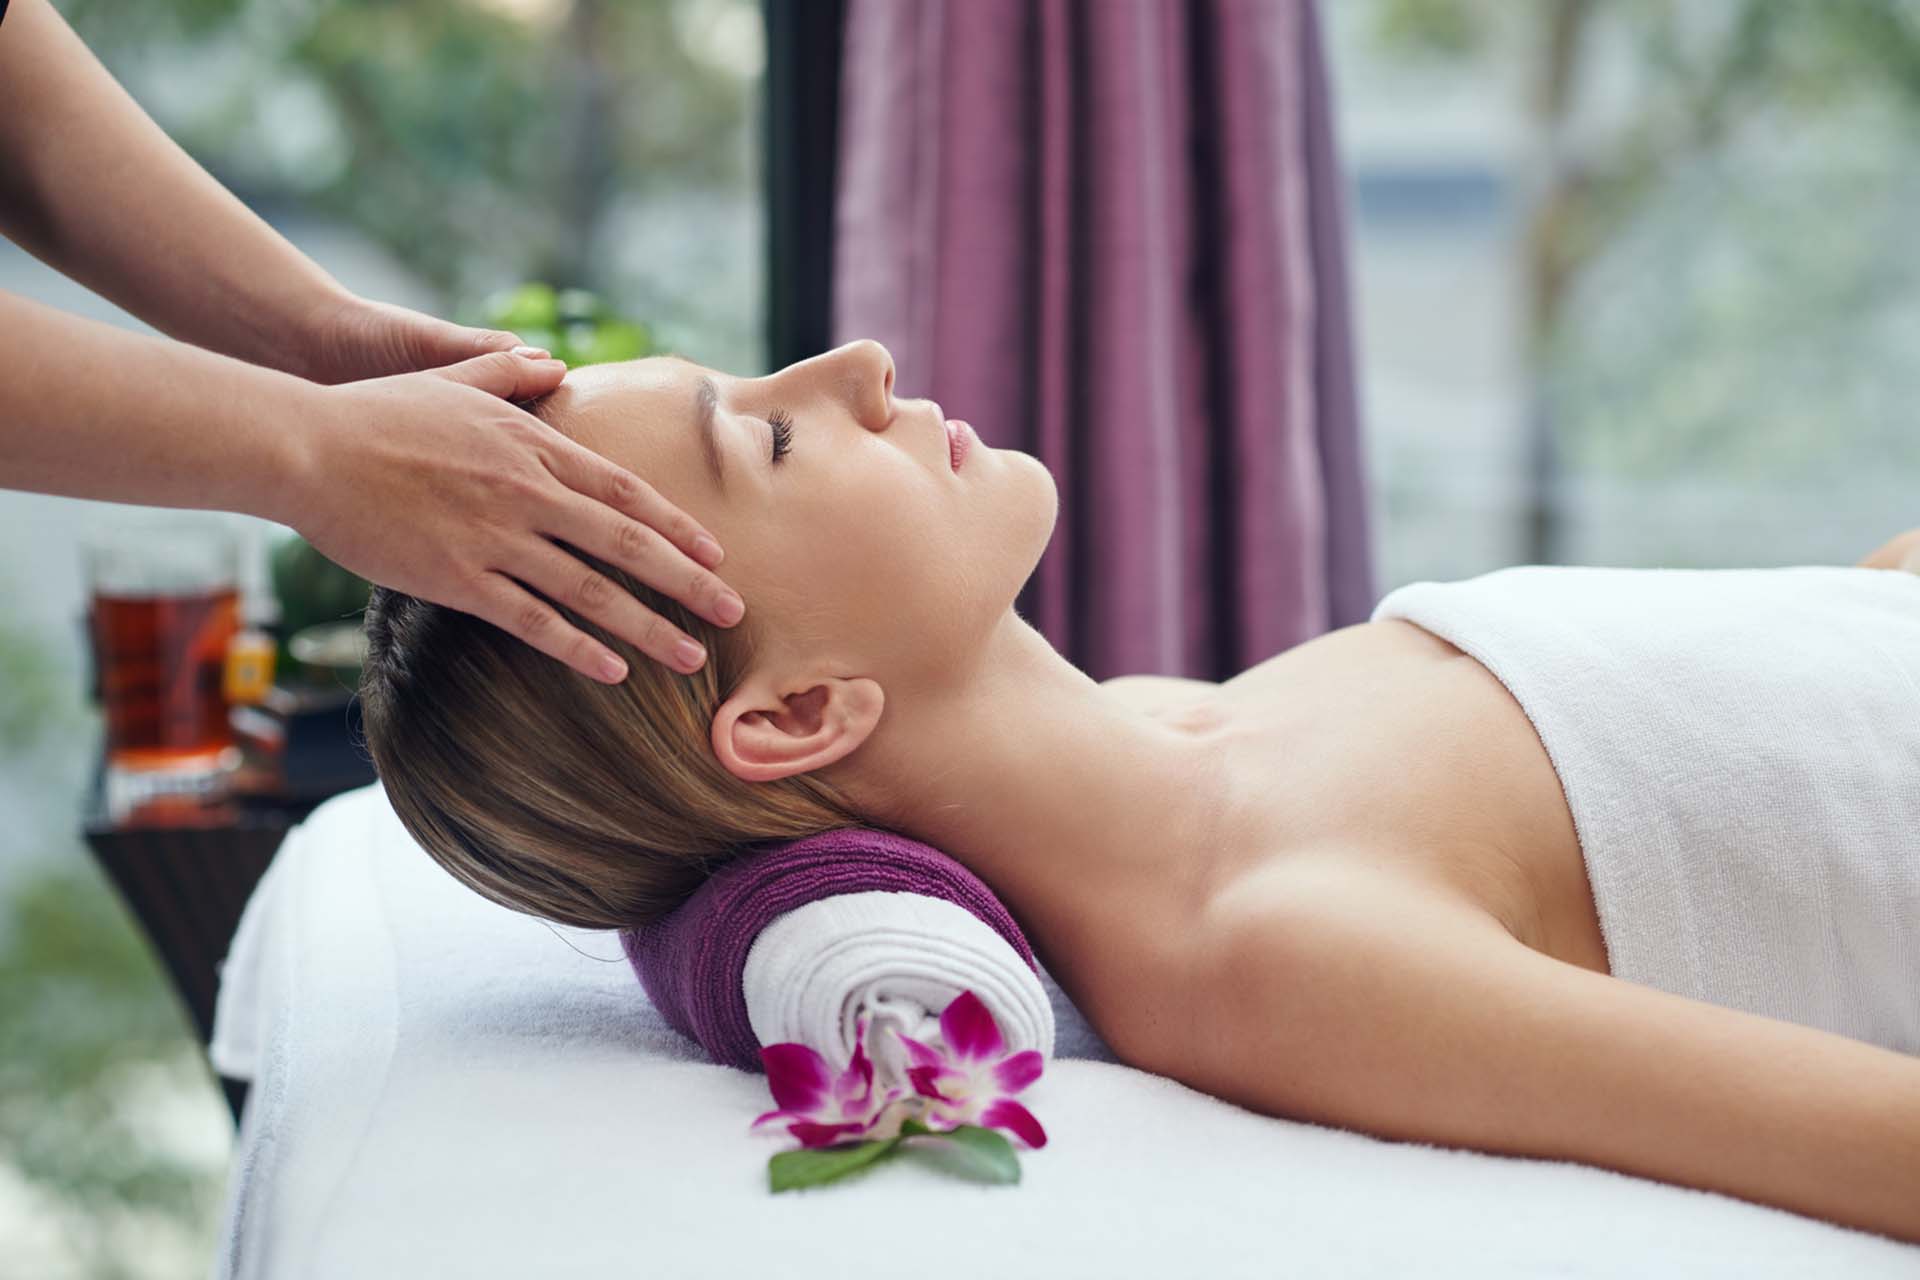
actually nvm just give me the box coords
[620,827,1039,1071]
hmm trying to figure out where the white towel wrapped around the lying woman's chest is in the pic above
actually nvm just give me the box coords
[1373,564,1920,1054]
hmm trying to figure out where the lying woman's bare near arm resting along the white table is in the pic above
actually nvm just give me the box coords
[1183,871,1920,1244]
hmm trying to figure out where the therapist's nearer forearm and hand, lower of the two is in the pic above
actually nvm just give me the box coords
[0,291,737,681]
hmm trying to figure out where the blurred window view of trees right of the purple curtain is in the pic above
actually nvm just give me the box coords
[1323,0,1920,589]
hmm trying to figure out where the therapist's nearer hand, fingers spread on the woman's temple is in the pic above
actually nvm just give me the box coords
[280,349,745,683]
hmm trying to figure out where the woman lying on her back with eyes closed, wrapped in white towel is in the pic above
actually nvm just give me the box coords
[363,342,1920,1242]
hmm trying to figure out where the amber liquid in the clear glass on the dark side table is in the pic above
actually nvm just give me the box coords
[90,587,240,770]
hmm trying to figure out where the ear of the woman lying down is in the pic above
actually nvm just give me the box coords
[712,676,887,783]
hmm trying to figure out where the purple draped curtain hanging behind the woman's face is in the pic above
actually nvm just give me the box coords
[833,0,1375,679]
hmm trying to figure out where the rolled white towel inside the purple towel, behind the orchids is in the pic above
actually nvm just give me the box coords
[741,890,1054,1086]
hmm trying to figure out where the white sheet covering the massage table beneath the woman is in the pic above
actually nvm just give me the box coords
[213,787,1920,1280]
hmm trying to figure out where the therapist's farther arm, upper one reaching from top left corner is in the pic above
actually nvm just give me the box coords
[0,0,516,382]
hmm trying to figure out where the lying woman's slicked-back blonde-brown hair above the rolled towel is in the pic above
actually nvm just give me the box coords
[359,433,862,929]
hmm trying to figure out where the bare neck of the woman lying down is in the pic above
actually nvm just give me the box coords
[833,612,1229,1000]
